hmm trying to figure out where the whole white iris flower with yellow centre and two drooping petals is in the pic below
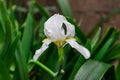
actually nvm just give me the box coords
[33,14,90,60]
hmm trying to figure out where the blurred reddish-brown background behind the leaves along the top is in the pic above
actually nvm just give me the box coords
[10,0,120,34]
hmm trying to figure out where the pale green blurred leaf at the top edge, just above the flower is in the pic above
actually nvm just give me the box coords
[57,0,73,18]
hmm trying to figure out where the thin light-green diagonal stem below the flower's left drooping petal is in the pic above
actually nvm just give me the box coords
[30,60,57,77]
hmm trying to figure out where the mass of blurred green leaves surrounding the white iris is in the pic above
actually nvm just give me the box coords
[0,0,120,80]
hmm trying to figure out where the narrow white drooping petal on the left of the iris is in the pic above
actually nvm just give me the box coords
[33,39,51,60]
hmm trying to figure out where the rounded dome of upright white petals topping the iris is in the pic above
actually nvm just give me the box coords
[44,14,75,41]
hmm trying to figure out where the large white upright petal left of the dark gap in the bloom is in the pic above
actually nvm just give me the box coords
[44,14,66,41]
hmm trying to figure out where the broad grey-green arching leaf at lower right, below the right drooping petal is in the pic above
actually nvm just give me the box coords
[74,60,115,80]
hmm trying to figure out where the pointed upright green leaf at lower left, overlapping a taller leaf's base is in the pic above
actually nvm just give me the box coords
[14,42,29,80]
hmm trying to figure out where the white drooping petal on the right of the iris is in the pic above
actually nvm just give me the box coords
[66,40,90,59]
